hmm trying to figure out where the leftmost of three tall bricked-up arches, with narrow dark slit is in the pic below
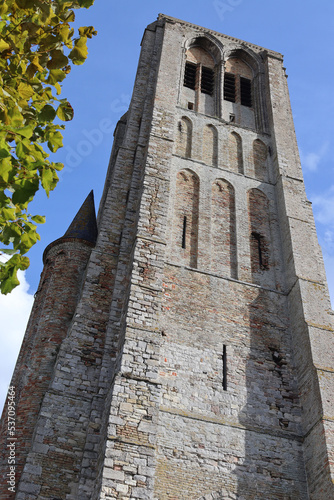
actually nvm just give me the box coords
[172,170,199,267]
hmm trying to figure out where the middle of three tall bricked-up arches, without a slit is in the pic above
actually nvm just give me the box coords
[211,179,237,279]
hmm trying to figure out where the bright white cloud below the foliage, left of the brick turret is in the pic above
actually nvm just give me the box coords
[0,271,34,412]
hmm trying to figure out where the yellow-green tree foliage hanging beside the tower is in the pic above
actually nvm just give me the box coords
[0,0,96,294]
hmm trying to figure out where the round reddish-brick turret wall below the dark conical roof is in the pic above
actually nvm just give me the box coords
[0,238,92,499]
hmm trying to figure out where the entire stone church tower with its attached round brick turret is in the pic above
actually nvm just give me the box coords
[0,15,334,500]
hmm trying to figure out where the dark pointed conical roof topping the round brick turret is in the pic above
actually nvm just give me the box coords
[63,191,97,245]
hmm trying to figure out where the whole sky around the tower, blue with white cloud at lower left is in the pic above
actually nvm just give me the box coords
[0,0,334,406]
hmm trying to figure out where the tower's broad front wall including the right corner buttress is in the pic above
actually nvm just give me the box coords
[95,15,333,500]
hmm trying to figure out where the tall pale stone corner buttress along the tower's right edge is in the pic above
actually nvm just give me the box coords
[268,52,334,499]
